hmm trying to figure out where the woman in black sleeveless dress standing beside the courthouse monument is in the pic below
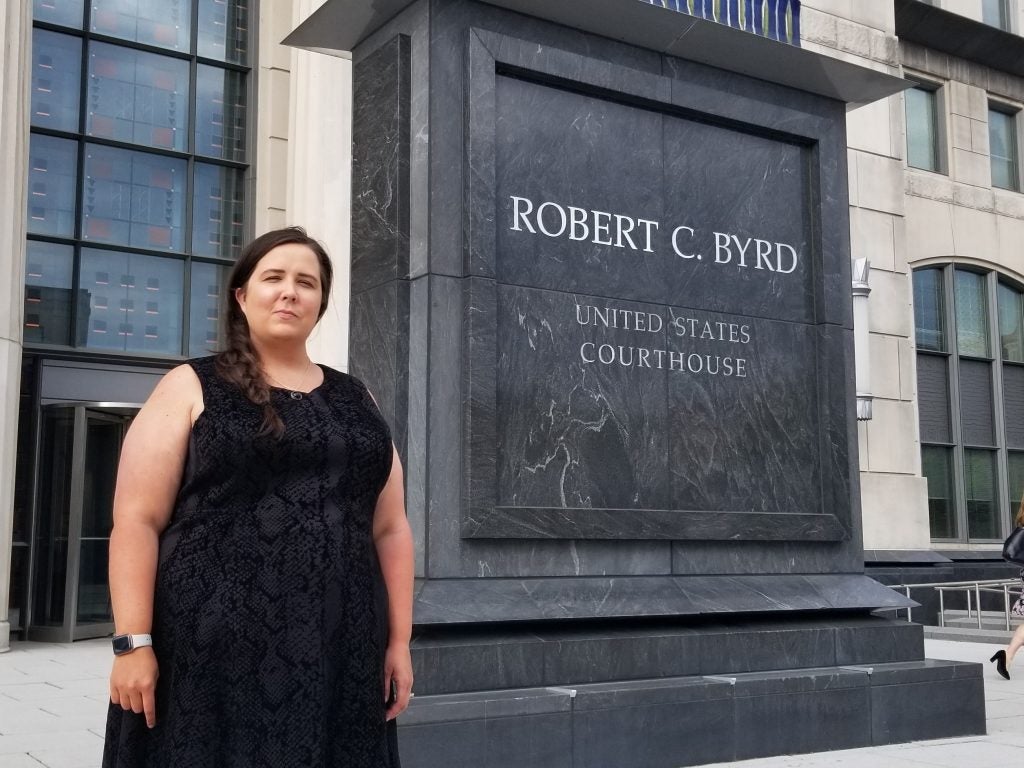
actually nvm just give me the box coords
[103,228,413,768]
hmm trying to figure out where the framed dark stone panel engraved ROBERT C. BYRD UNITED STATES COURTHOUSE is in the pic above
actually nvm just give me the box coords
[462,18,851,541]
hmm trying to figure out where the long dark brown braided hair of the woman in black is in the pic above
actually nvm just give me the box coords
[216,226,334,437]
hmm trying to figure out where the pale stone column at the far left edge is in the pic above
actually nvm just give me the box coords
[0,0,32,652]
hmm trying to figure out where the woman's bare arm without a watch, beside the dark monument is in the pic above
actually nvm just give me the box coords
[374,446,414,720]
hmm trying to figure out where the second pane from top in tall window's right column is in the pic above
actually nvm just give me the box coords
[196,65,246,162]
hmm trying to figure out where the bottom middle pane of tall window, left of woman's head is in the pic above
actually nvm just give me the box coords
[78,248,184,354]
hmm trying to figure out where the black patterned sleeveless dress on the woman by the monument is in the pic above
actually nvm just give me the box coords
[103,357,399,768]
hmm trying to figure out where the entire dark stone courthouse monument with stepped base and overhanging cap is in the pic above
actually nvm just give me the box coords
[289,0,984,768]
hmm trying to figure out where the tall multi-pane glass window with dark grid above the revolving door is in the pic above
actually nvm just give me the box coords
[25,0,252,356]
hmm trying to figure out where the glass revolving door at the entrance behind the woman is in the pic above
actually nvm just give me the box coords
[28,402,138,642]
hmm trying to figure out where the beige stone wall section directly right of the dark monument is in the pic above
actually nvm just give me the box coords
[801,0,931,549]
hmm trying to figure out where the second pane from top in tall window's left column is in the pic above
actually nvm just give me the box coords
[32,30,82,131]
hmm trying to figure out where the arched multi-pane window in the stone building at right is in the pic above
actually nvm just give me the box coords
[913,264,1024,542]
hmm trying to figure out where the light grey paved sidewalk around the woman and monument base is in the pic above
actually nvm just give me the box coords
[0,639,1024,768]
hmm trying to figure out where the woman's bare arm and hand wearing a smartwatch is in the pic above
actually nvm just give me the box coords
[110,366,203,728]
